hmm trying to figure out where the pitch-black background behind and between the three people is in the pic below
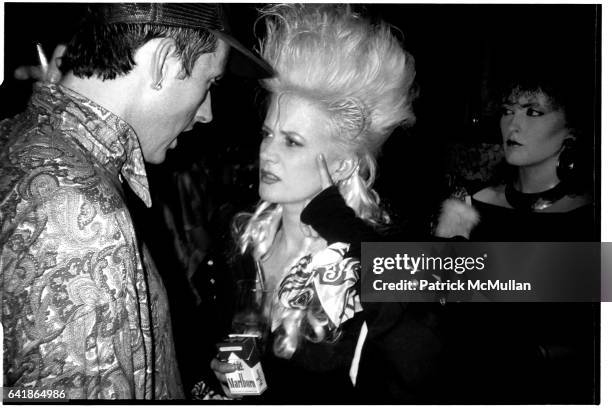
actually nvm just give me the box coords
[0,3,601,396]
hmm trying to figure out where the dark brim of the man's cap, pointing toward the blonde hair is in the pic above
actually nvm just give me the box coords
[210,30,275,78]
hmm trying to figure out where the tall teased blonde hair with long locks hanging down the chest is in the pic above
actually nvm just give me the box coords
[236,4,415,358]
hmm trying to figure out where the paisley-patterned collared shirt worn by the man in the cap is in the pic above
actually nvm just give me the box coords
[0,84,183,399]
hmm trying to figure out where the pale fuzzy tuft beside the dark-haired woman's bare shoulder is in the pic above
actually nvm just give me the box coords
[434,198,480,239]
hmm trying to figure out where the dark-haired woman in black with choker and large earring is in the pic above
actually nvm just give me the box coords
[436,71,599,404]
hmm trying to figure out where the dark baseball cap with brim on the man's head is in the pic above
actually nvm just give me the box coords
[103,3,274,78]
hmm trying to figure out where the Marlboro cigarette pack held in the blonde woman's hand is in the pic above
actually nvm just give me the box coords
[217,335,268,395]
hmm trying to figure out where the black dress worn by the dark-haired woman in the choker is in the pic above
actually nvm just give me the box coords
[445,199,600,404]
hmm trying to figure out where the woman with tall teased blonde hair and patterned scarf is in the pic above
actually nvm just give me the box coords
[212,4,415,403]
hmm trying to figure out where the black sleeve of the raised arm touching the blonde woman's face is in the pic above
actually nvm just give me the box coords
[301,186,381,257]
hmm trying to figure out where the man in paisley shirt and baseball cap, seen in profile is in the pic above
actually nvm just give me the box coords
[0,3,271,399]
